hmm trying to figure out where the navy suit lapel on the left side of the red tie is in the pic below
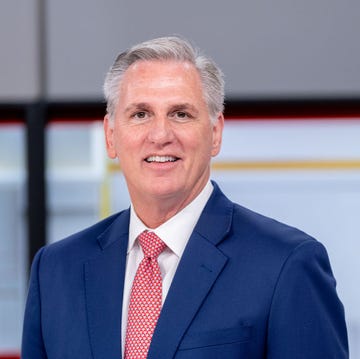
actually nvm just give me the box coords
[84,211,129,359]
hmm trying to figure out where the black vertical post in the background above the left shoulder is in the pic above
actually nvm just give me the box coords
[26,102,46,264]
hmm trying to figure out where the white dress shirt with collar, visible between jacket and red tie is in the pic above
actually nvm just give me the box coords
[121,181,213,353]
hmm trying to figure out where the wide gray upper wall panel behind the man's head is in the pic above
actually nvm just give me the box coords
[48,0,360,98]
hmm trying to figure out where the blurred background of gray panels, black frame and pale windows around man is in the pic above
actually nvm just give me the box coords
[0,0,360,359]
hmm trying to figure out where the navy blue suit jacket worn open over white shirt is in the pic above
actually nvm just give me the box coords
[22,185,348,359]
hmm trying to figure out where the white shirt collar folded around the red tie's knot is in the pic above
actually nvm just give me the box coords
[128,181,214,257]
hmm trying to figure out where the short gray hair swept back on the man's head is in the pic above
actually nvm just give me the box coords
[104,36,224,123]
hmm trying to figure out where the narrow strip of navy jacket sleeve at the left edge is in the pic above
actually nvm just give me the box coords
[21,249,47,359]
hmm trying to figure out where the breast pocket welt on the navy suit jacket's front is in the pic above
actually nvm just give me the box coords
[179,325,251,350]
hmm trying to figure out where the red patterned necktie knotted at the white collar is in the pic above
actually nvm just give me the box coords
[125,231,166,359]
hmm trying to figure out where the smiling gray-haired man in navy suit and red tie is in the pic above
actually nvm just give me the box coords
[22,37,348,359]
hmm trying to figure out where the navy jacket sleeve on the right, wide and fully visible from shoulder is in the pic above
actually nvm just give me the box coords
[267,240,349,359]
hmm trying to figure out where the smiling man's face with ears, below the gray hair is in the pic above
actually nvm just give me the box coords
[105,61,223,208]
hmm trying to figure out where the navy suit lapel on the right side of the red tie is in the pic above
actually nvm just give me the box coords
[148,184,233,359]
